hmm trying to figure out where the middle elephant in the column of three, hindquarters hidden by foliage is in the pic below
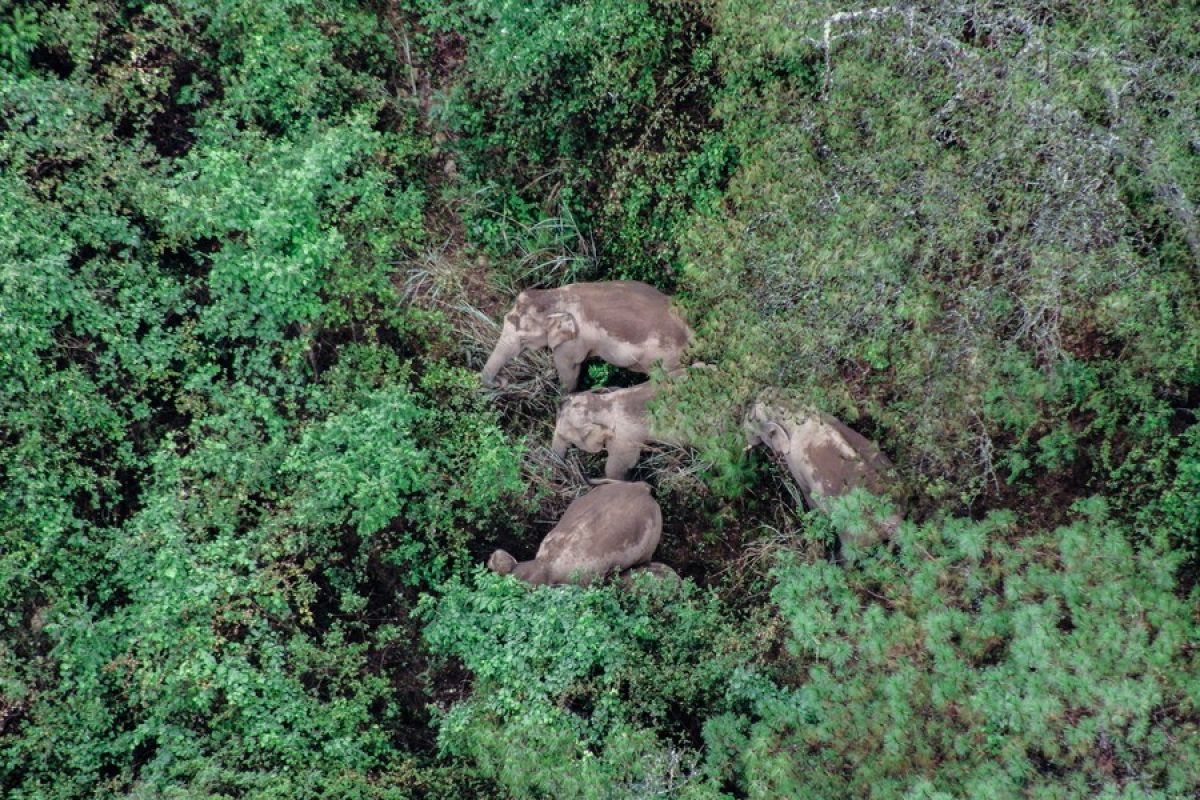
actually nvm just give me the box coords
[551,383,686,480]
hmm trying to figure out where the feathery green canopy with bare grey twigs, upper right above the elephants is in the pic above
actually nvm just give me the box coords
[680,0,1200,498]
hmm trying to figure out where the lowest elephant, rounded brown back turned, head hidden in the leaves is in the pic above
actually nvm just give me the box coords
[487,482,662,584]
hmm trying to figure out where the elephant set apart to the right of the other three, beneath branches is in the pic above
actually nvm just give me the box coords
[744,402,900,547]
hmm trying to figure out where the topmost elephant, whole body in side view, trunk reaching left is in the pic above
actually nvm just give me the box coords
[480,281,691,392]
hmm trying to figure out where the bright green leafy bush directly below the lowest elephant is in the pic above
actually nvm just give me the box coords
[424,573,750,798]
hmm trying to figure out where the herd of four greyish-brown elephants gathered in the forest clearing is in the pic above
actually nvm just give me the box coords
[481,281,900,584]
